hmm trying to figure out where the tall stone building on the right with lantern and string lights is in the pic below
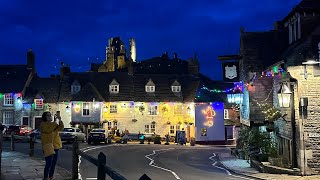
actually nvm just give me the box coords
[225,0,320,174]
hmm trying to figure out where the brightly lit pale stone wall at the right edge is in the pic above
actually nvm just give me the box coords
[288,66,320,174]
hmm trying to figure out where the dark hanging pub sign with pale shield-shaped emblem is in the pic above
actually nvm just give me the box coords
[222,62,239,82]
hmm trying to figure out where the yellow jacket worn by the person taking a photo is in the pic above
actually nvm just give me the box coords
[40,122,63,157]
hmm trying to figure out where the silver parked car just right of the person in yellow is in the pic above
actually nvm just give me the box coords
[60,128,86,142]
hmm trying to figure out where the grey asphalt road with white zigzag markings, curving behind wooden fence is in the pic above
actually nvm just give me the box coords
[4,141,250,180]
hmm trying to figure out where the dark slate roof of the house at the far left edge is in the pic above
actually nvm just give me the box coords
[0,65,30,93]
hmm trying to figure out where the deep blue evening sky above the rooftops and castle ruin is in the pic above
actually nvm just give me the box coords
[0,0,300,80]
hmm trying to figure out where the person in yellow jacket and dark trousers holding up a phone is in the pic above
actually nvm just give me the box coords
[40,112,63,180]
